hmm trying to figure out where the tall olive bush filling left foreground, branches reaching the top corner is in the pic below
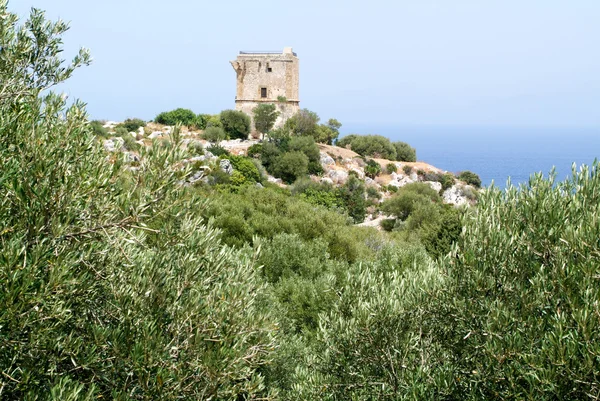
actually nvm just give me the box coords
[0,8,276,400]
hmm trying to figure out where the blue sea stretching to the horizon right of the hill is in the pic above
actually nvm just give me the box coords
[342,125,600,188]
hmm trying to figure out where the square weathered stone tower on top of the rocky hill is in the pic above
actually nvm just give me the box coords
[231,47,300,127]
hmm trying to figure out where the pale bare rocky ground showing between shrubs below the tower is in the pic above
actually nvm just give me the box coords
[103,121,477,220]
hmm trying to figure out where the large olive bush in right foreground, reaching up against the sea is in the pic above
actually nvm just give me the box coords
[432,162,600,400]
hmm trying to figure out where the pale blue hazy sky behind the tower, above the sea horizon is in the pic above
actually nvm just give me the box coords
[9,0,600,126]
